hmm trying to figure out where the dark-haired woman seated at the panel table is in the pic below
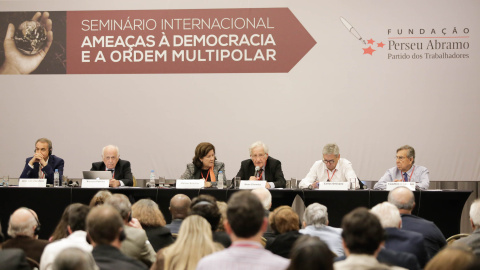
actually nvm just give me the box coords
[180,142,227,187]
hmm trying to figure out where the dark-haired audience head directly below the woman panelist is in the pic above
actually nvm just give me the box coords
[190,195,221,231]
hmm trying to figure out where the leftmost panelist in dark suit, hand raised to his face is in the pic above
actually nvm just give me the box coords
[20,138,64,185]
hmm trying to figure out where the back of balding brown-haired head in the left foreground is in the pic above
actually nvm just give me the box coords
[87,205,123,245]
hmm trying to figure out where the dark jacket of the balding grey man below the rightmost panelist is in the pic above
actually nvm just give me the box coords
[402,214,447,258]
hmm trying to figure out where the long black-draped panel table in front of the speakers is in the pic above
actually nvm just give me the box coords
[0,187,472,239]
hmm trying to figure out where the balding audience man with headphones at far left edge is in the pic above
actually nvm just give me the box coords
[2,207,48,262]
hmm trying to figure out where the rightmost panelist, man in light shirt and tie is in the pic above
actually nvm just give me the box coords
[373,145,430,190]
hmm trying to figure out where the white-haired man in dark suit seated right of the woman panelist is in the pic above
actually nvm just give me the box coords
[237,141,285,188]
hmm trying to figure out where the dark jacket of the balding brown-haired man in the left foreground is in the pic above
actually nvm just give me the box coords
[92,245,148,270]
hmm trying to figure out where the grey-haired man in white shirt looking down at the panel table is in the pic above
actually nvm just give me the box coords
[298,143,359,189]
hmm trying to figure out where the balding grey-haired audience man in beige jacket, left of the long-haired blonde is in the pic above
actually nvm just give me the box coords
[105,194,155,266]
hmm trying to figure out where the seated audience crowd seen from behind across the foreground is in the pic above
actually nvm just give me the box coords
[0,187,480,270]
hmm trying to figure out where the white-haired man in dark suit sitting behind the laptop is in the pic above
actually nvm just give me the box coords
[90,145,133,187]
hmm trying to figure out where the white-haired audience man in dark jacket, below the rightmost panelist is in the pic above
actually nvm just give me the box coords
[371,202,428,268]
